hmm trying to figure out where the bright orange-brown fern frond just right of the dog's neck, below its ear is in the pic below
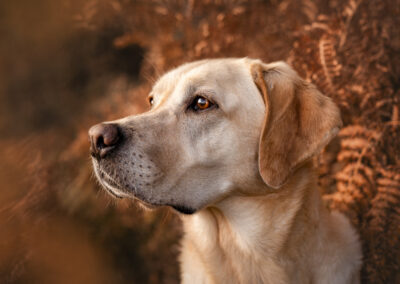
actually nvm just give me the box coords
[328,125,381,225]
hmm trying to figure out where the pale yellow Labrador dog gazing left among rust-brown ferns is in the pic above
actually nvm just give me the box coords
[89,58,362,284]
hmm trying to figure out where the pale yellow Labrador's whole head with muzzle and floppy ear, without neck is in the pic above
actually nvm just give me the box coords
[89,58,341,213]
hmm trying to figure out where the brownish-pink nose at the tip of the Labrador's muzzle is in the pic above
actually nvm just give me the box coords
[89,123,121,159]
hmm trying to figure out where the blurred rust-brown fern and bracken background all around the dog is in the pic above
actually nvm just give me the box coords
[0,0,400,283]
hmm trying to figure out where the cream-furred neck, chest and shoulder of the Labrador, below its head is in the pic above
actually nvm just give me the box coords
[180,163,361,284]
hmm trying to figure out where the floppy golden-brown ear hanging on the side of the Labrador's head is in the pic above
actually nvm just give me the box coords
[251,62,342,188]
